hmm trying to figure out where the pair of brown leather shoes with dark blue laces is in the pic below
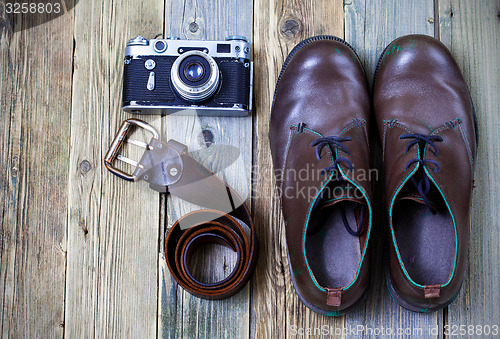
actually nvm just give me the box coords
[270,35,477,315]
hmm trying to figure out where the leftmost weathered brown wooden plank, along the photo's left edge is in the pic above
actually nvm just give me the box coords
[0,4,73,338]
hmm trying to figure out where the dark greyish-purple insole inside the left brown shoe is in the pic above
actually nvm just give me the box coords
[306,202,361,288]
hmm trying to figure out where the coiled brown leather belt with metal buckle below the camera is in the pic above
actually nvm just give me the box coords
[104,119,258,299]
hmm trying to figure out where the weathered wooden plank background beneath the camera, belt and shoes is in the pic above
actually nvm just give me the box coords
[0,0,500,338]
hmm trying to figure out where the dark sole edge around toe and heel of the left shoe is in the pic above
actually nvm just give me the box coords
[271,35,371,317]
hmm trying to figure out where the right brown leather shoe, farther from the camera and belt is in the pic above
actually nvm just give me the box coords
[373,35,477,312]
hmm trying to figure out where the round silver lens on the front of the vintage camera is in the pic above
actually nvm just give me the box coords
[170,51,220,102]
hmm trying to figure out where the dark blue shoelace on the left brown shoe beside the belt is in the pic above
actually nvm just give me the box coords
[311,136,365,236]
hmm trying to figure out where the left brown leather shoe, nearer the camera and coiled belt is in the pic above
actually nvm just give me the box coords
[269,36,372,315]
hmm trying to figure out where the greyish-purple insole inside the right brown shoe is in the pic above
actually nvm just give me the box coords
[393,200,455,285]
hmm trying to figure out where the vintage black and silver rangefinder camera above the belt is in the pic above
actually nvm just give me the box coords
[123,36,253,116]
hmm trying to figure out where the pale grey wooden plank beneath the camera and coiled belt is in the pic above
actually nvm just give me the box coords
[158,0,252,338]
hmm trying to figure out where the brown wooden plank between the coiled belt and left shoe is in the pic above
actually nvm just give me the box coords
[252,0,344,338]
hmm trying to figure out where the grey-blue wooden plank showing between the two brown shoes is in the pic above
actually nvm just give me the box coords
[345,0,442,338]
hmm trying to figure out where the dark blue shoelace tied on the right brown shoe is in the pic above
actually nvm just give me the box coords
[399,133,443,214]
